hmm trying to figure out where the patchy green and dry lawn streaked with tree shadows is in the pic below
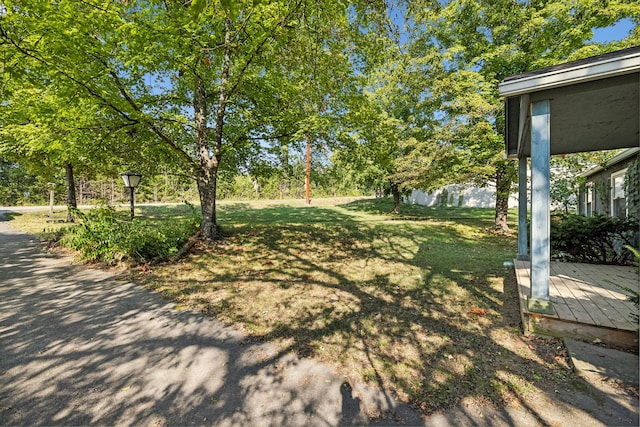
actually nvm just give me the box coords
[6,199,575,413]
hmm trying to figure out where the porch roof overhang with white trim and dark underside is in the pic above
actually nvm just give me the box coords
[499,46,640,158]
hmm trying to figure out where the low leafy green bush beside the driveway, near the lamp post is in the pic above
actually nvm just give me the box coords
[61,206,198,264]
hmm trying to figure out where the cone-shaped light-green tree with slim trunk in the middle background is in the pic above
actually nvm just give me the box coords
[335,9,452,212]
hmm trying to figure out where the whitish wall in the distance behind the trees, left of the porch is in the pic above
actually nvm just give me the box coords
[404,185,518,208]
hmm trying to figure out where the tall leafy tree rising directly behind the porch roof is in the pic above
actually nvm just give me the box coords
[398,0,640,230]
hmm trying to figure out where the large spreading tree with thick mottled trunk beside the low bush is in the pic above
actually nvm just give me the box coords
[0,0,376,239]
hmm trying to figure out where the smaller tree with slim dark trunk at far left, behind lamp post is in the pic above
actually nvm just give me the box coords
[0,80,131,220]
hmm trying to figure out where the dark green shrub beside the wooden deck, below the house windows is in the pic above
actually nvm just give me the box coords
[551,214,638,265]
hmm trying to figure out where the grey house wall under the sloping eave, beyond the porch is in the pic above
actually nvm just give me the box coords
[578,155,638,216]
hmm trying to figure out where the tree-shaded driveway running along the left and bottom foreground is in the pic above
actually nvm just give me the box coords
[0,216,638,426]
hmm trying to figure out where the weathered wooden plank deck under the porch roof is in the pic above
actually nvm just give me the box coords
[515,261,640,348]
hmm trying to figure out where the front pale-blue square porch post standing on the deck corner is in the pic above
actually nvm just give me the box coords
[527,99,554,314]
